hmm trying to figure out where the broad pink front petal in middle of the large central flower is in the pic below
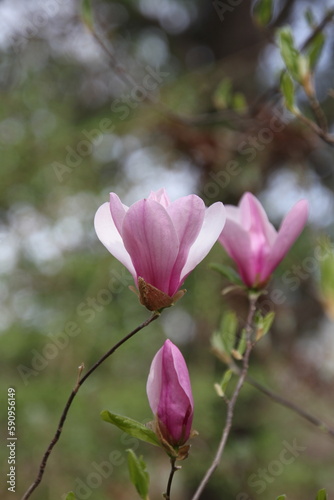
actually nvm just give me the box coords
[122,200,179,294]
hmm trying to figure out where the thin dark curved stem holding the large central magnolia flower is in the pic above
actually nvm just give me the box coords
[21,313,160,500]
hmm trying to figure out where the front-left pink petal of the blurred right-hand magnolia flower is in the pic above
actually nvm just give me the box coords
[219,219,258,287]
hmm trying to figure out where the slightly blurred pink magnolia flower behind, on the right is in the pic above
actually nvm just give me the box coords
[219,193,308,288]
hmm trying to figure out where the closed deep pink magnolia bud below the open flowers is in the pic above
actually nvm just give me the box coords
[146,340,194,447]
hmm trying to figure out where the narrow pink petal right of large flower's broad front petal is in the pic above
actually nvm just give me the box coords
[167,195,206,296]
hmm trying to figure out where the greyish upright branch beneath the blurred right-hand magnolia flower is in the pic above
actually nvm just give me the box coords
[192,295,257,500]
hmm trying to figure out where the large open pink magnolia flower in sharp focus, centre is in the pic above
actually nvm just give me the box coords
[95,189,225,310]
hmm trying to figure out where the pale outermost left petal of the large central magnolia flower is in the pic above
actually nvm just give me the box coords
[94,203,137,280]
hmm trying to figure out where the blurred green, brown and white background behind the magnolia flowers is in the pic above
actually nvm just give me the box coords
[0,0,334,500]
